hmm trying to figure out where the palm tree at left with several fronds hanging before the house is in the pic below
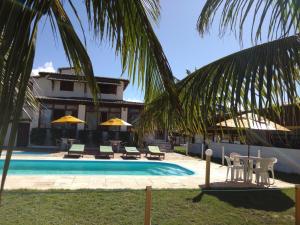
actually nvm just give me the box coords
[0,0,175,200]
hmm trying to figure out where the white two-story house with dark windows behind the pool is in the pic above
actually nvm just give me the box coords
[6,68,143,146]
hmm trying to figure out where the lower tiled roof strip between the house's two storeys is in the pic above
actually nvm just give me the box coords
[36,96,144,108]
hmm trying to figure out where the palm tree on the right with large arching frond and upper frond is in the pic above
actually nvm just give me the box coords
[140,0,300,137]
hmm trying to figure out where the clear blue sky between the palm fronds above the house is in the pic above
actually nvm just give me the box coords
[33,0,255,101]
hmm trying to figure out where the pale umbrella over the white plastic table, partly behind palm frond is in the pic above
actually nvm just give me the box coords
[216,113,290,157]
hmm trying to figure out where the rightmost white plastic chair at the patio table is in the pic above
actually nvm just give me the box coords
[254,158,273,185]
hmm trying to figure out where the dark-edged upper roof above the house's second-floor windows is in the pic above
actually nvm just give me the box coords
[34,72,129,90]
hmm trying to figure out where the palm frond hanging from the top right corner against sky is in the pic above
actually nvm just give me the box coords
[197,0,300,41]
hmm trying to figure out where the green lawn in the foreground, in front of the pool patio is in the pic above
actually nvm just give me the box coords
[0,189,295,225]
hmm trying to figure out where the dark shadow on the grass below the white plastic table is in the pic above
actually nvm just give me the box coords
[192,189,295,212]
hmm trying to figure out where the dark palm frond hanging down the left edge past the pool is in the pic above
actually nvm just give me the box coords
[0,1,41,198]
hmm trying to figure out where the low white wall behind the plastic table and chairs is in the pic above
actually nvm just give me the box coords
[189,142,300,174]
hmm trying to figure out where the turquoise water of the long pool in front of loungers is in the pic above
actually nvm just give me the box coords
[0,160,194,176]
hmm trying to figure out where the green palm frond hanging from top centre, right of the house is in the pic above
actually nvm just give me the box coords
[85,0,174,102]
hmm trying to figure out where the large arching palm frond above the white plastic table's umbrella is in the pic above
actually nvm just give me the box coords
[181,35,300,133]
